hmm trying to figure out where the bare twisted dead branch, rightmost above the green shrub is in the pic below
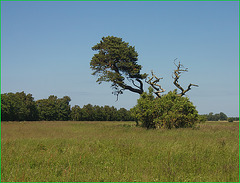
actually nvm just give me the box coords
[173,60,198,96]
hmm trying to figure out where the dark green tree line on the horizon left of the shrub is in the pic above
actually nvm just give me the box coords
[1,92,134,121]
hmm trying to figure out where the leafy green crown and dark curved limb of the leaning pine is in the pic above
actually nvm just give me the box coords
[90,36,147,98]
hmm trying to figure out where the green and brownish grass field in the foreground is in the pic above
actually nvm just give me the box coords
[1,121,239,182]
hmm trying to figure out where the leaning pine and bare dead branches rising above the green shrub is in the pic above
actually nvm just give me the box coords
[90,36,198,99]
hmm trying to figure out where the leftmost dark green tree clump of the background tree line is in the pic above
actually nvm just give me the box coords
[1,92,38,121]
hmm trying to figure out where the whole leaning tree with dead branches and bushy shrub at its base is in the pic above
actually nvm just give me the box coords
[90,36,200,129]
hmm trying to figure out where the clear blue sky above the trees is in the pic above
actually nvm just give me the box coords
[1,1,239,116]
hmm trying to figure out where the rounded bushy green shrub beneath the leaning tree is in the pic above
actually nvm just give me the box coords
[131,88,202,129]
